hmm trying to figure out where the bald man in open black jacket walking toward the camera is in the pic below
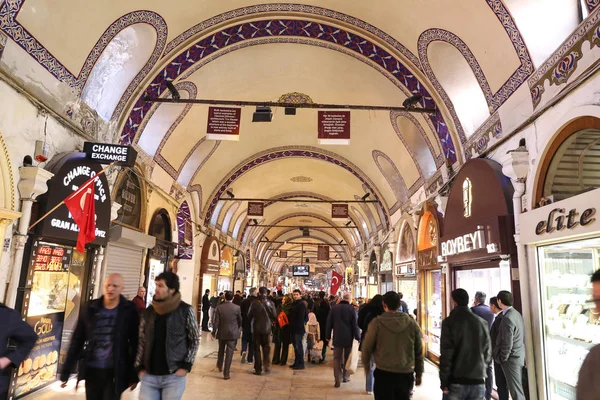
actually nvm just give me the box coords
[60,274,139,400]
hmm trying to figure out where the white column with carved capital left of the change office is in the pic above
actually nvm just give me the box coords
[6,167,54,308]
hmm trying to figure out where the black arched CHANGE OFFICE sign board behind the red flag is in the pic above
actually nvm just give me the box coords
[37,153,111,246]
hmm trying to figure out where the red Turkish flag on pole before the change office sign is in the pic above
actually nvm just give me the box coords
[65,176,96,253]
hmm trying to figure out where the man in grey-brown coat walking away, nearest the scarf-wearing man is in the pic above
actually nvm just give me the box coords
[212,290,242,380]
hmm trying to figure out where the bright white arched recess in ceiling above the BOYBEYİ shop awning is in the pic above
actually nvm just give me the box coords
[427,41,490,137]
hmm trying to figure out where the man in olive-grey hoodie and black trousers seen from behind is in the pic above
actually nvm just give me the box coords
[361,292,424,400]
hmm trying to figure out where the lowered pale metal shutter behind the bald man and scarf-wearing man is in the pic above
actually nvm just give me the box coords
[105,243,144,300]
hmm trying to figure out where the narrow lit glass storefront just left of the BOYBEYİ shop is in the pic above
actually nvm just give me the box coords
[425,269,443,356]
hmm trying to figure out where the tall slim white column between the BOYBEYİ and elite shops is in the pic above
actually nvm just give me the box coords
[501,146,544,400]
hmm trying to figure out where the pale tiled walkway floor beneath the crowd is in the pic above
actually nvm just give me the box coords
[35,333,442,400]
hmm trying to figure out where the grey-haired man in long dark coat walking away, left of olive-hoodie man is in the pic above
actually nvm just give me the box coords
[326,293,360,388]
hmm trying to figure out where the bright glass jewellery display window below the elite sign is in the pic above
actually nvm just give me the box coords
[537,238,600,400]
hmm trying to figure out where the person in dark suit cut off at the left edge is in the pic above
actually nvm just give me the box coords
[0,303,37,400]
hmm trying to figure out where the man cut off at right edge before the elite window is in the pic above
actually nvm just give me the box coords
[577,269,600,400]
